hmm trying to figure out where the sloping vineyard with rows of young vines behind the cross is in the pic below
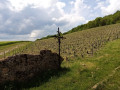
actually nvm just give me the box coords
[23,24,120,60]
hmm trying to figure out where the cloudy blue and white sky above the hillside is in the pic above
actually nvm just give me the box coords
[0,0,120,41]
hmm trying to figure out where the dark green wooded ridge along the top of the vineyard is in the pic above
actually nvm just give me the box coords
[64,11,120,34]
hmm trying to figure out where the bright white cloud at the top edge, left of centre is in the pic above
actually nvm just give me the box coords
[8,0,57,12]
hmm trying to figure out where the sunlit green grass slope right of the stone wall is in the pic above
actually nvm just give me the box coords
[27,39,120,90]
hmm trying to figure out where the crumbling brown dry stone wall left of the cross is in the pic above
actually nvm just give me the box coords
[0,50,63,83]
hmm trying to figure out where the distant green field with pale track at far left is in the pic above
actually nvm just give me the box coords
[0,41,31,59]
